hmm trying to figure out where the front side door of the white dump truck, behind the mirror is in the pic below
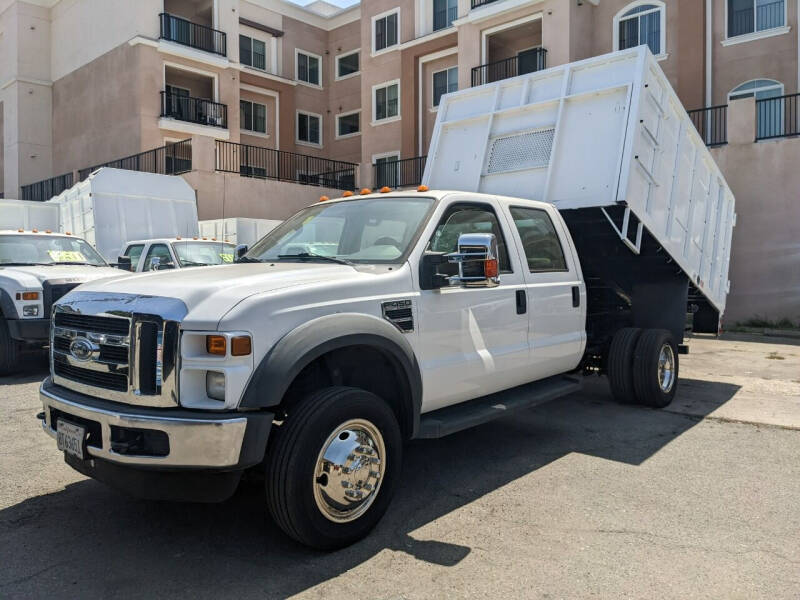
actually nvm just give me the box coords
[412,196,529,412]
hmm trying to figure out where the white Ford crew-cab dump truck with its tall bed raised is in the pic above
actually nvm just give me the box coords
[40,48,734,549]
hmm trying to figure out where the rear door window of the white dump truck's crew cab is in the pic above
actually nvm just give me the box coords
[511,207,569,273]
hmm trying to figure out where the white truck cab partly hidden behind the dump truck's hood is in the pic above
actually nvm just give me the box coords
[119,237,236,273]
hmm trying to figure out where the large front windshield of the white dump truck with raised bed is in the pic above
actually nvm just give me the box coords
[250,196,433,263]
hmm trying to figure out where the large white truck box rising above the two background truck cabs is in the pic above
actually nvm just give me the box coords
[49,167,198,263]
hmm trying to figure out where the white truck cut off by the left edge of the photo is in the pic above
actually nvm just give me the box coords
[0,229,120,375]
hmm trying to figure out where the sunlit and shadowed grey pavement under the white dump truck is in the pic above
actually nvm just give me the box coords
[0,338,800,600]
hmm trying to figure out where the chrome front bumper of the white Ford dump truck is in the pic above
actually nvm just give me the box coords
[39,378,274,471]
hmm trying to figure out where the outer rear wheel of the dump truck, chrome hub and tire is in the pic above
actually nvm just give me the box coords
[633,329,678,408]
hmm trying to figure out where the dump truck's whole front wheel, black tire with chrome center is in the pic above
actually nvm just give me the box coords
[266,387,402,550]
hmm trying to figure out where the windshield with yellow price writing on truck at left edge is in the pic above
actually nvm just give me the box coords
[0,235,108,267]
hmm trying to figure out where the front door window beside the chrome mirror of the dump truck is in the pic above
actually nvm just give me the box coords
[428,204,512,275]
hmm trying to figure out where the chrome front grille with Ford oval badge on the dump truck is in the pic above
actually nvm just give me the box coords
[50,292,185,407]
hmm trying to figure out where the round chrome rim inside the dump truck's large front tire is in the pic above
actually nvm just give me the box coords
[314,419,386,523]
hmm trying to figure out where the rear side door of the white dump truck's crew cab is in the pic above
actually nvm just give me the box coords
[503,201,586,379]
